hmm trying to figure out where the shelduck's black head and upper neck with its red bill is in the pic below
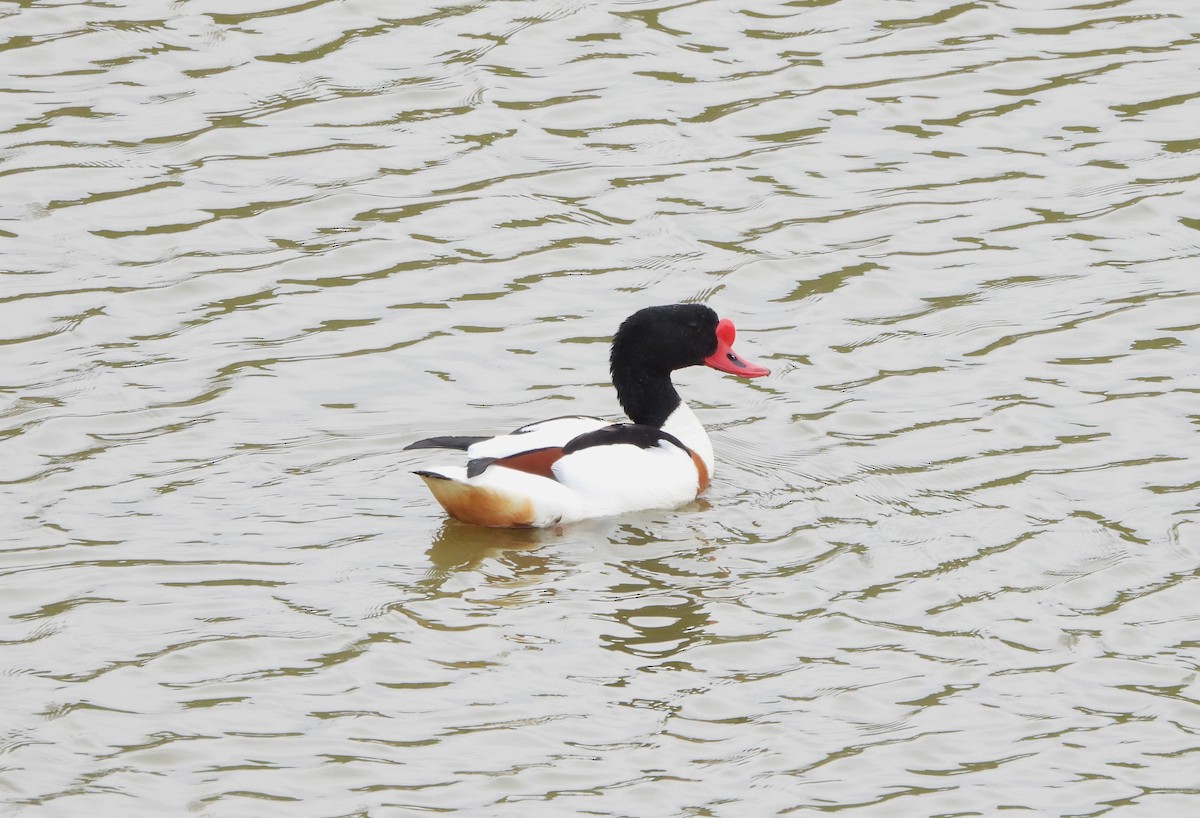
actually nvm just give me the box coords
[610,303,769,426]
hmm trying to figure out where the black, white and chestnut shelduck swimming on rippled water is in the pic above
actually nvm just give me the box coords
[404,303,770,528]
